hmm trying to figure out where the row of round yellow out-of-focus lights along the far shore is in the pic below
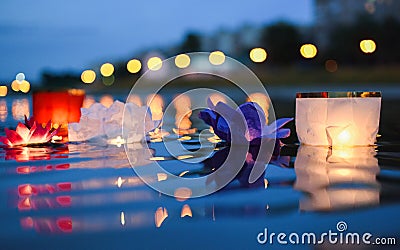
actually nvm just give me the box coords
[0,39,376,97]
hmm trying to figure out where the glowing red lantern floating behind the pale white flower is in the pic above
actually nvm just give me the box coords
[32,89,85,136]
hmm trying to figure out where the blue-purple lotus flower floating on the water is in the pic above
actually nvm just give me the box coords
[199,99,293,145]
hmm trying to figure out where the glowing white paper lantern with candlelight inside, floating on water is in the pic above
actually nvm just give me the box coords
[296,92,382,147]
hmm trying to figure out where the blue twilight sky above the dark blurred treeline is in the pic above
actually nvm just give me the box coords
[0,0,313,84]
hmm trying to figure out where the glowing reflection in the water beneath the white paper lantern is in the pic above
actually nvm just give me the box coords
[294,146,379,211]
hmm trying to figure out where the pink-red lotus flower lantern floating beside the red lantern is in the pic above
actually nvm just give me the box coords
[0,116,58,147]
